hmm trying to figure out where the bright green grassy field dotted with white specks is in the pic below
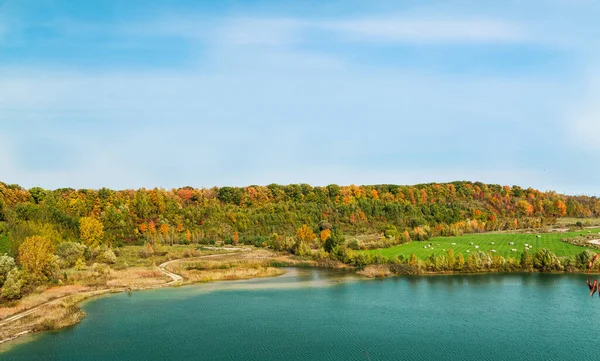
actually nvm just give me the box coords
[364,228,600,259]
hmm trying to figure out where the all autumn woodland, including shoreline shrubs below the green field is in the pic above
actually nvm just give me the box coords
[0,181,600,298]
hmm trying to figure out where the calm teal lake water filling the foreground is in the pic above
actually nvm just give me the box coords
[0,270,600,361]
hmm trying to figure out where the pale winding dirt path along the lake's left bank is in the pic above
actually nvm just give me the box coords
[0,252,237,344]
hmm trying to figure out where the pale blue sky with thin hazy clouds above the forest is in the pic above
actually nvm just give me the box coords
[0,0,600,195]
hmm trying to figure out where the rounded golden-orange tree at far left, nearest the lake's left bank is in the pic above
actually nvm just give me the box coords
[19,236,54,278]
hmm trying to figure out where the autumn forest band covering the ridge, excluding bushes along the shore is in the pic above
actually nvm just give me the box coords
[0,182,600,256]
